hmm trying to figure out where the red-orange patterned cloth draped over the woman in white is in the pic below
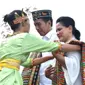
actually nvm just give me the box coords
[53,40,85,85]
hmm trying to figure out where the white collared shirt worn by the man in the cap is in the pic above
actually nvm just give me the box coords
[39,30,58,85]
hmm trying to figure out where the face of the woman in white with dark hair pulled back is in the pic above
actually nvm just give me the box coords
[56,22,72,42]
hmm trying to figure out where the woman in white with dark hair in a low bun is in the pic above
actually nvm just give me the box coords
[45,16,82,85]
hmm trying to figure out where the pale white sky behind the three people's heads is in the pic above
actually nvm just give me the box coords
[0,0,85,41]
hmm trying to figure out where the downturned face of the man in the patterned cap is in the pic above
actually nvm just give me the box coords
[34,19,51,36]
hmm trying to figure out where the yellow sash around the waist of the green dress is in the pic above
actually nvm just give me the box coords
[0,59,20,70]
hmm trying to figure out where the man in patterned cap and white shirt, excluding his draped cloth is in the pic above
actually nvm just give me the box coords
[32,10,57,85]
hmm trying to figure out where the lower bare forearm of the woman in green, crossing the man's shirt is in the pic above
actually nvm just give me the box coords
[33,56,53,66]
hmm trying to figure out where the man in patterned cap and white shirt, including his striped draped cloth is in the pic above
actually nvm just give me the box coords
[22,10,81,85]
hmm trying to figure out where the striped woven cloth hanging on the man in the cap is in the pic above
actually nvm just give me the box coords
[22,52,41,85]
